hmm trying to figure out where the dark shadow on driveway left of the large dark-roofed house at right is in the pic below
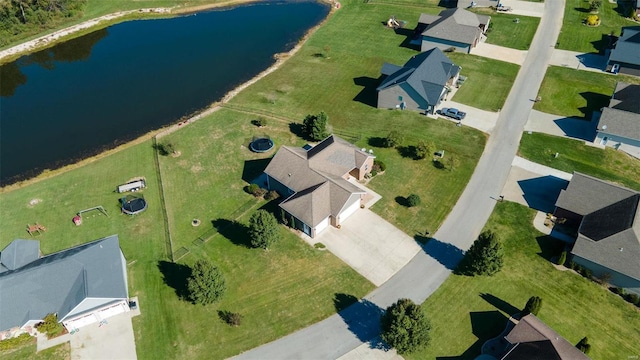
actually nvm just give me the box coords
[518,175,569,213]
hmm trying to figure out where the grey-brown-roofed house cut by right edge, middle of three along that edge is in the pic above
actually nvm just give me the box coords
[594,83,640,158]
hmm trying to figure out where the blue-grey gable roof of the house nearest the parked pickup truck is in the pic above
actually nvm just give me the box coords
[376,48,461,104]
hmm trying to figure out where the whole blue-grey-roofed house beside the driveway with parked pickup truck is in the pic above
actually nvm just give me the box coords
[376,48,461,114]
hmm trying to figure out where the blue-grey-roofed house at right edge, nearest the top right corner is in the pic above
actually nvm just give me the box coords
[607,26,640,76]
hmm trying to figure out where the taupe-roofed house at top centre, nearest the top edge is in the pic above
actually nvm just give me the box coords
[411,8,491,54]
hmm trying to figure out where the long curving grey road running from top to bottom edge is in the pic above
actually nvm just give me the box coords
[232,0,565,359]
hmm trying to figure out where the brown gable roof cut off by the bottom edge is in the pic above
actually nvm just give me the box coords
[502,314,589,360]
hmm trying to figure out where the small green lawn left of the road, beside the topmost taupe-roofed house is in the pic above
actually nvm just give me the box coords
[473,8,540,50]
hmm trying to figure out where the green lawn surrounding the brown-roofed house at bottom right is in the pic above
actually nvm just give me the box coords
[405,202,640,359]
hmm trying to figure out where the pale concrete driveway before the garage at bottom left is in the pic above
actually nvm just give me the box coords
[70,310,139,360]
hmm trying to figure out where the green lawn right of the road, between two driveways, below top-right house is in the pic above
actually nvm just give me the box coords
[536,66,640,119]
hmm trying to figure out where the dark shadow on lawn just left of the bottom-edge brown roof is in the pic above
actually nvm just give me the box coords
[436,310,509,360]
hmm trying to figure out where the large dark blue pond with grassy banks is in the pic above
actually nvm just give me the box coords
[0,1,329,186]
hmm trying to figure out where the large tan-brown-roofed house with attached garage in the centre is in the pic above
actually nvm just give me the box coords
[264,135,375,237]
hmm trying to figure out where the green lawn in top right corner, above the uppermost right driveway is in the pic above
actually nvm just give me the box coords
[557,0,637,54]
